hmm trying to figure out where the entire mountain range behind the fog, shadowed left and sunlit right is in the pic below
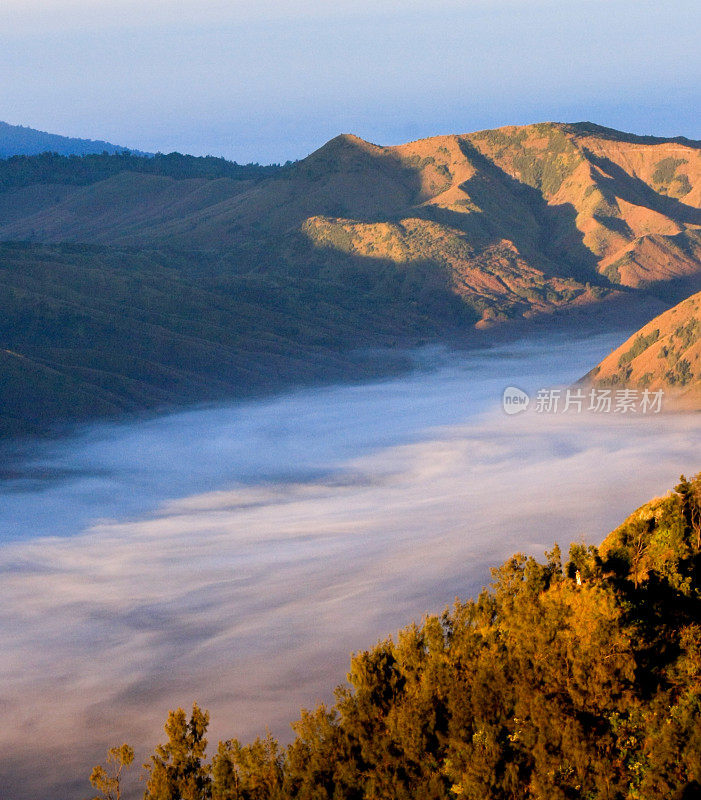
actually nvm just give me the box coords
[0,123,701,431]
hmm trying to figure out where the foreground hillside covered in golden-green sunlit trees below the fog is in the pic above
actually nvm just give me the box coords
[92,475,701,800]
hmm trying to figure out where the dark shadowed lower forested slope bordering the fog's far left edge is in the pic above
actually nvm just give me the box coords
[0,244,469,436]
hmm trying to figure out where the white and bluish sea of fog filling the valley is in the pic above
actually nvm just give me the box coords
[0,332,701,800]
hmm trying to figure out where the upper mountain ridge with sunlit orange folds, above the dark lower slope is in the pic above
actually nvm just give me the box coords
[0,123,701,326]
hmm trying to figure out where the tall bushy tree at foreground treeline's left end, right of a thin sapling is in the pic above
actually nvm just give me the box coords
[144,703,212,800]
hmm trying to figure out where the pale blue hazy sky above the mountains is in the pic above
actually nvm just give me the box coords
[0,0,701,162]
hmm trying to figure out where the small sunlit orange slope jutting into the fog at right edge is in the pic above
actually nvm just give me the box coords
[587,292,701,409]
